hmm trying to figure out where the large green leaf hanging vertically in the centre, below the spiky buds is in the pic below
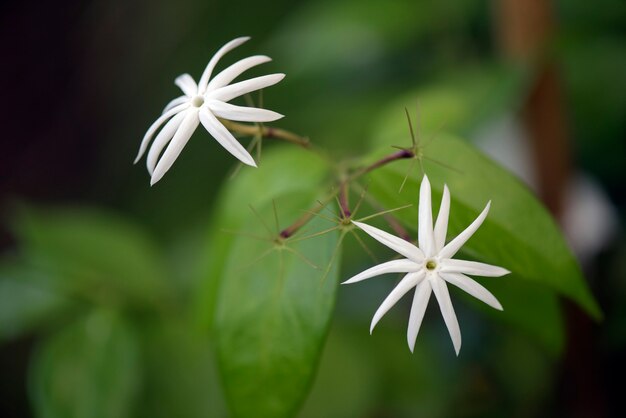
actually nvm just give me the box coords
[201,149,339,417]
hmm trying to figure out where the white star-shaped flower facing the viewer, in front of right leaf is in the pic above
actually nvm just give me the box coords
[343,176,510,355]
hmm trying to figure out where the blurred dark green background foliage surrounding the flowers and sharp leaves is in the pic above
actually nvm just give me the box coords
[0,0,626,417]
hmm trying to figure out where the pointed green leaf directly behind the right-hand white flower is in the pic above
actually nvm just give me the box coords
[369,135,601,318]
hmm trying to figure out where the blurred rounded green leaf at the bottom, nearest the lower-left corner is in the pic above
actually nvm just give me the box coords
[29,311,139,418]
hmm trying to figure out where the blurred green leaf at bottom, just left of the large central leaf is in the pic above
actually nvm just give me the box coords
[137,318,226,418]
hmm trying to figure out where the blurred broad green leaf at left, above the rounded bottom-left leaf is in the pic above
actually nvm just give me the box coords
[16,208,168,304]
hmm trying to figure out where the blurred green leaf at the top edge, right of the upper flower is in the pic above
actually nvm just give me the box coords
[272,0,483,77]
